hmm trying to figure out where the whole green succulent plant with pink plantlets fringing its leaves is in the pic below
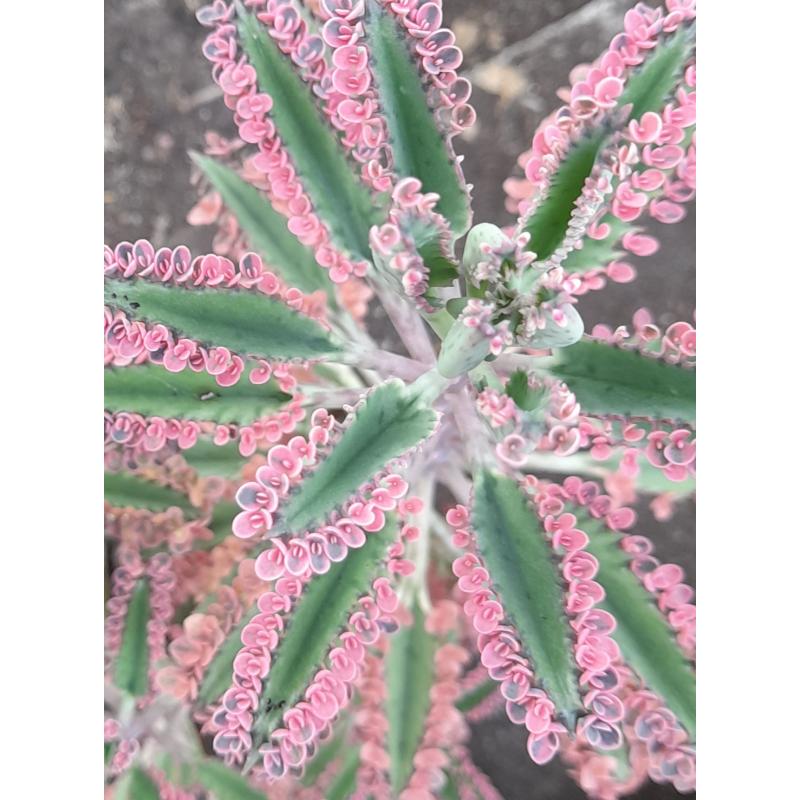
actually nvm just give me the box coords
[104,0,695,800]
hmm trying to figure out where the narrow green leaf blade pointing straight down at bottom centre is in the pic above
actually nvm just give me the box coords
[386,603,436,796]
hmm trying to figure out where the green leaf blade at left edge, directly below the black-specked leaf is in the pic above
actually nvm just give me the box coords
[104,364,291,425]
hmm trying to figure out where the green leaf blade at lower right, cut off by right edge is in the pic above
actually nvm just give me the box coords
[578,514,696,740]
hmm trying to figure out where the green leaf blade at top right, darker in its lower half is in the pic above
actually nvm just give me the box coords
[524,29,694,261]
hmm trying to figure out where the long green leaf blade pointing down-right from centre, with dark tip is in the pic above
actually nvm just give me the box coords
[472,468,582,731]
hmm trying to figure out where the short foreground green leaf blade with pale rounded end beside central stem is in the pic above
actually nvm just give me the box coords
[273,380,436,533]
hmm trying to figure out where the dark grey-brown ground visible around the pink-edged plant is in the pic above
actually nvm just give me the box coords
[105,0,695,800]
